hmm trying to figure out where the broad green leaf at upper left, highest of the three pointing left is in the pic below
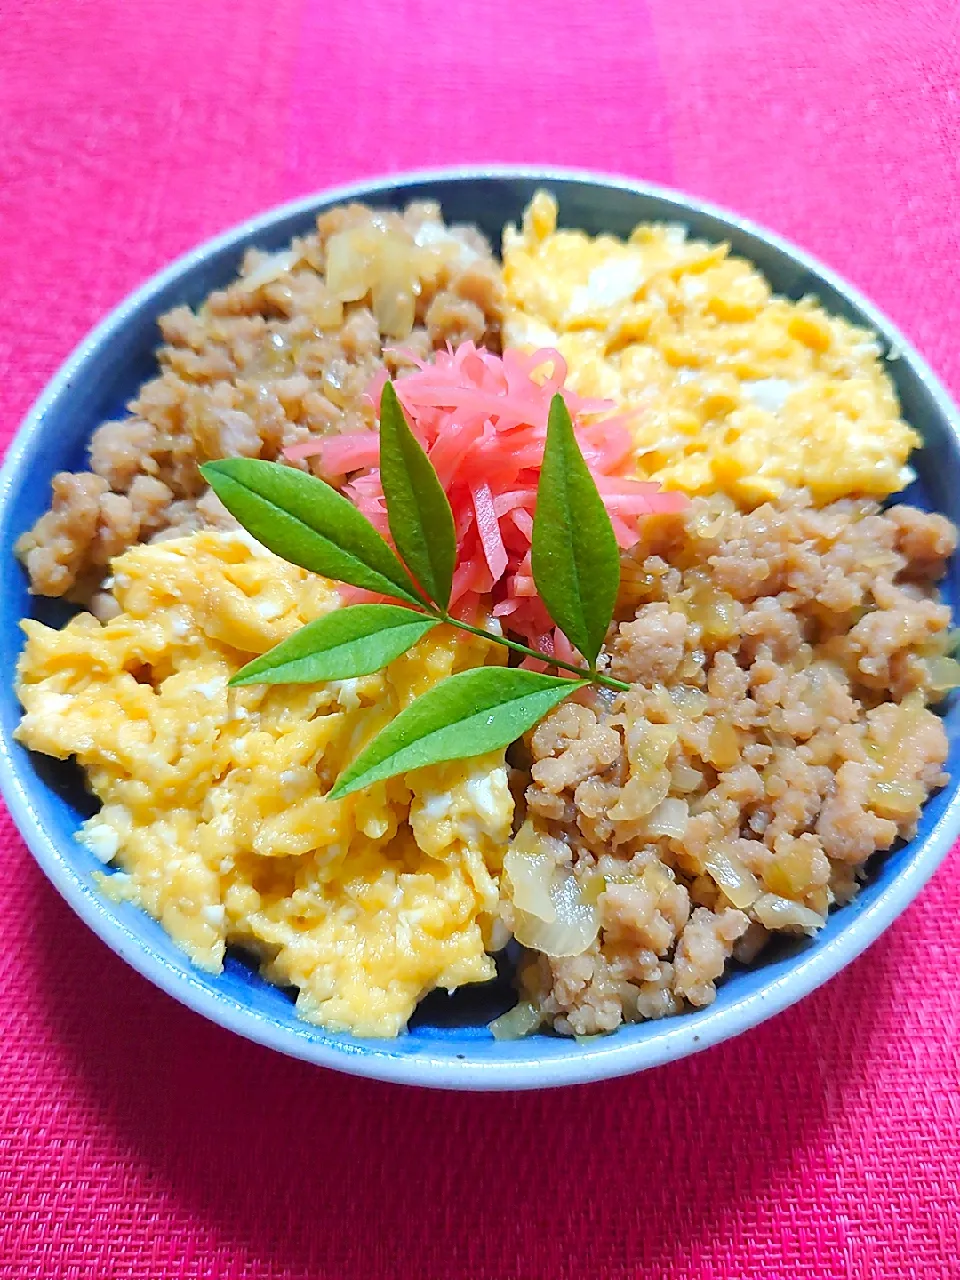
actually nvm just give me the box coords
[200,458,421,604]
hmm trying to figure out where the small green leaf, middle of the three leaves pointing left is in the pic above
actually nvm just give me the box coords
[230,604,439,685]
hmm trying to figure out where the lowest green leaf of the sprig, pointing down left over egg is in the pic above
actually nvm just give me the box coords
[330,667,588,800]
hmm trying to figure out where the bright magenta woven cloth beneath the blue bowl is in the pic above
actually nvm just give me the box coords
[0,0,960,1280]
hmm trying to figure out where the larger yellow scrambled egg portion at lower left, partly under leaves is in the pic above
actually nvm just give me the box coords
[17,532,513,1036]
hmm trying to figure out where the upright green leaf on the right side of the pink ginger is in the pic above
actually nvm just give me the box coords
[531,393,620,667]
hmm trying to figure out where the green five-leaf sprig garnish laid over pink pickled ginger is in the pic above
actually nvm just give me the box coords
[201,381,630,799]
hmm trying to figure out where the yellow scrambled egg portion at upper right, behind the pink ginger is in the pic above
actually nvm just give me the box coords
[503,192,919,506]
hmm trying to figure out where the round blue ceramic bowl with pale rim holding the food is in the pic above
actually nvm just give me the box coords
[0,168,960,1089]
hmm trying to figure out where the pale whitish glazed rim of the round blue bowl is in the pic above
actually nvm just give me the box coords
[0,165,960,1091]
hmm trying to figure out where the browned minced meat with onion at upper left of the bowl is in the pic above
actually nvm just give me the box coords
[17,204,502,614]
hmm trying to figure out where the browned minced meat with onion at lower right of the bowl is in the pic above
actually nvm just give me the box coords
[504,493,960,1034]
